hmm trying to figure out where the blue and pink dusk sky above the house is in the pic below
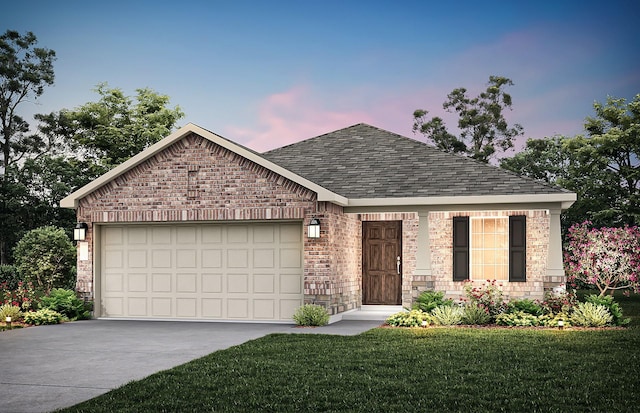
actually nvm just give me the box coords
[0,0,640,151]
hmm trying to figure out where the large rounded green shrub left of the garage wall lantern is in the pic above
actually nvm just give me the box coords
[13,227,76,293]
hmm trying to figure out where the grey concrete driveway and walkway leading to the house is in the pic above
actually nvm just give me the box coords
[0,320,381,413]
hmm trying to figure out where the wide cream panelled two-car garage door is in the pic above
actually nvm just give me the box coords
[99,223,303,321]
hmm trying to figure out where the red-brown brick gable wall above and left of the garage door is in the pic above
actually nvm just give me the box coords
[77,134,316,298]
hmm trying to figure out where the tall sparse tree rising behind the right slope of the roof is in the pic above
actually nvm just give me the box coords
[413,76,523,162]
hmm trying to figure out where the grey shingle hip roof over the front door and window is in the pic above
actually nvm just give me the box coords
[262,123,569,198]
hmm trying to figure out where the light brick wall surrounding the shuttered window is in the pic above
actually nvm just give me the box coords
[429,210,549,299]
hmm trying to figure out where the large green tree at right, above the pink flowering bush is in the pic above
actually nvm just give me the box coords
[501,95,640,230]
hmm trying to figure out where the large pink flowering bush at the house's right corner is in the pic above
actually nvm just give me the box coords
[564,222,640,296]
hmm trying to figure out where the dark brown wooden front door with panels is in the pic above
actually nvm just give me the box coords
[362,221,402,305]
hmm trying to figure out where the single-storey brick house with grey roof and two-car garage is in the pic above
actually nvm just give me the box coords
[61,124,576,322]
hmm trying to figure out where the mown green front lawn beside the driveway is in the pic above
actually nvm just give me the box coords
[58,296,640,412]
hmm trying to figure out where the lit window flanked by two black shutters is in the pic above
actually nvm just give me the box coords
[453,216,527,282]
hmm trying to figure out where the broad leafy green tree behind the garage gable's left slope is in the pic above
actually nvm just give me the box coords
[58,83,184,173]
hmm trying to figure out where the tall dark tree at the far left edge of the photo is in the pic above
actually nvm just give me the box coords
[0,30,55,264]
